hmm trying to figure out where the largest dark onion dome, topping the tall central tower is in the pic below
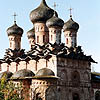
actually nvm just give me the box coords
[30,0,57,23]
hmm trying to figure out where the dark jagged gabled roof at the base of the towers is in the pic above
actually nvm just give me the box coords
[0,43,96,64]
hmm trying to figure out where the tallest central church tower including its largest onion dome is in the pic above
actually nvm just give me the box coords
[30,0,57,45]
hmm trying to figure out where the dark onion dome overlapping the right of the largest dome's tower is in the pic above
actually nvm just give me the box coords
[46,14,64,27]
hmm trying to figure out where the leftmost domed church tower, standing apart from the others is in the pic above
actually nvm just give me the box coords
[7,15,23,50]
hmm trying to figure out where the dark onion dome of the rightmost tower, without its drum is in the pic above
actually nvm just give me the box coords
[63,18,79,31]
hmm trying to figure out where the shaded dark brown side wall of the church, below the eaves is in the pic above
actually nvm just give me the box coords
[57,58,91,100]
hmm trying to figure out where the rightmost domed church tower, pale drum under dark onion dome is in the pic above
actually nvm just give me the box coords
[63,9,79,48]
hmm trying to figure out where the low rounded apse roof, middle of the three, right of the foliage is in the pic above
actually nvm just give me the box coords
[12,69,35,79]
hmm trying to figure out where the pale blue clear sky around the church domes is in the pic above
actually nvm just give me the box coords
[0,0,100,72]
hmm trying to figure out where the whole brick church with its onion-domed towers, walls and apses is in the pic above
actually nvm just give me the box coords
[0,0,100,100]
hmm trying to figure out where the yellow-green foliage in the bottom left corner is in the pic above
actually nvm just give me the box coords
[0,74,24,100]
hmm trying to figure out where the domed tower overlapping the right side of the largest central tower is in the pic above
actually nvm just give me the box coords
[46,12,64,44]
